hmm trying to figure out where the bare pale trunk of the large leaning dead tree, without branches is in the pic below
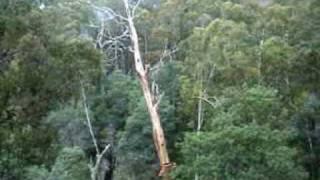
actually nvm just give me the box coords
[123,0,173,176]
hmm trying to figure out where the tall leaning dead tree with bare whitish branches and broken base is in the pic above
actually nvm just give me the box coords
[90,0,177,176]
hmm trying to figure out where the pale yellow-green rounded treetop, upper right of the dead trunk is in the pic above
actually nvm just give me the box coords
[185,19,255,83]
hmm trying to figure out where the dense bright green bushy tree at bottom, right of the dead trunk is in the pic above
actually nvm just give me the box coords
[175,86,305,180]
